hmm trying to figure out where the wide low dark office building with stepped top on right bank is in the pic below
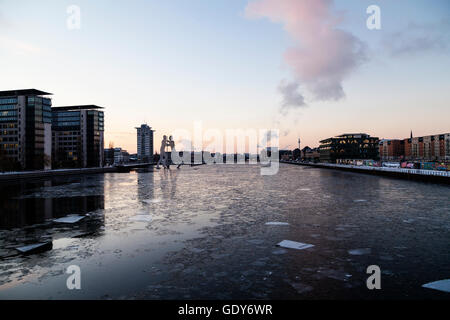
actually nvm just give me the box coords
[319,133,379,163]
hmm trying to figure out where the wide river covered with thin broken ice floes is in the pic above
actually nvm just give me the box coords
[0,165,450,299]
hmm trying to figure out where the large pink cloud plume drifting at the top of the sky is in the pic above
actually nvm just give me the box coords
[246,0,366,100]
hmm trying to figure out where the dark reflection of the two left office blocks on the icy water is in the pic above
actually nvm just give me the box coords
[0,175,105,258]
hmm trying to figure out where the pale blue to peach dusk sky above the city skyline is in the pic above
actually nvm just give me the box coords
[0,0,450,152]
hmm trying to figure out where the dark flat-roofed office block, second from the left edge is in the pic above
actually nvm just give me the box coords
[52,105,104,168]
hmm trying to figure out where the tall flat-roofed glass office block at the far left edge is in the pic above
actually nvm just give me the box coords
[0,89,52,170]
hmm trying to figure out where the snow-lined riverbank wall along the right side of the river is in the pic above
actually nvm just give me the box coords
[281,161,450,184]
